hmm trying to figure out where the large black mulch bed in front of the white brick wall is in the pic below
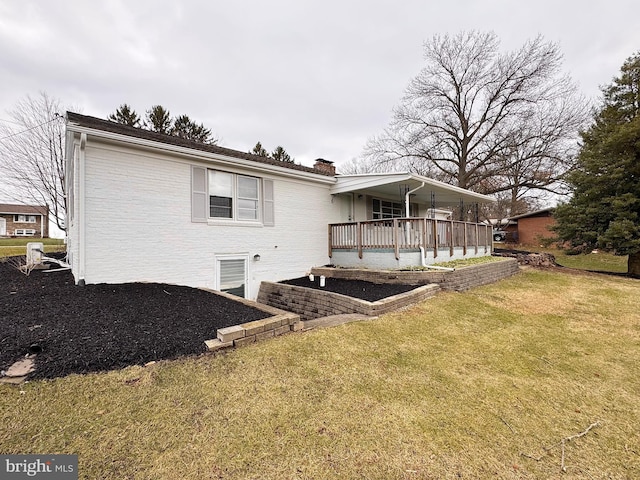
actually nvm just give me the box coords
[0,261,269,378]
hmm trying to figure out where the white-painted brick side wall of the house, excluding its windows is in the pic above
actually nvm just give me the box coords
[69,137,343,299]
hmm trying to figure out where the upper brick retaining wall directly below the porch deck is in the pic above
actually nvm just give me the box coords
[311,258,519,291]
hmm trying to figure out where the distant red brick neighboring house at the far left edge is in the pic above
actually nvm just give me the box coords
[0,203,49,238]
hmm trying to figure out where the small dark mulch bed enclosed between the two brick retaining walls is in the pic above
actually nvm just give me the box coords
[281,276,418,302]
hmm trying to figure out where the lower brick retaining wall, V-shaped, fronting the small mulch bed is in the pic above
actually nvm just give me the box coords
[258,282,440,321]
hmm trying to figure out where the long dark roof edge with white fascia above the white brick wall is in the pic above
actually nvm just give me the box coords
[67,112,336,184]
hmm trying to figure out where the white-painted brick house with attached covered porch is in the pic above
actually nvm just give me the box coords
[66,112,492,299]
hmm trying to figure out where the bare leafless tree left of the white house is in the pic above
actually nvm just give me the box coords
[0,92,67,230]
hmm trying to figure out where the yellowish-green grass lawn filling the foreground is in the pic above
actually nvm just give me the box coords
[0,269,640,479]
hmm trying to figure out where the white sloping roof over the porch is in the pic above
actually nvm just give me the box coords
[331,172,495,207]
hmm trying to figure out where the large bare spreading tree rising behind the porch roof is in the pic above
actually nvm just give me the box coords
[365,31,589,212]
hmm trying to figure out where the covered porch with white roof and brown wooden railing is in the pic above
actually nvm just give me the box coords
[328,173,493,269]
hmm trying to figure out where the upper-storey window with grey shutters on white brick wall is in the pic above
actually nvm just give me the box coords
[191,166,273,226]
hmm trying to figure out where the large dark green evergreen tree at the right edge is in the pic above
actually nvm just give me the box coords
[555,52,640,277]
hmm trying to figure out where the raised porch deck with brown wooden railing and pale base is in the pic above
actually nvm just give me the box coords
[329,218,493,268]
